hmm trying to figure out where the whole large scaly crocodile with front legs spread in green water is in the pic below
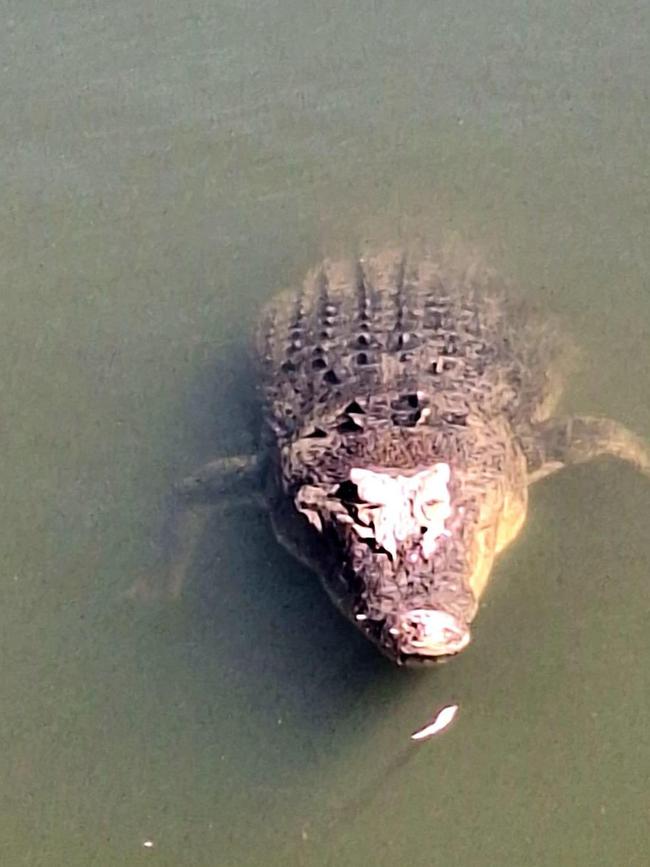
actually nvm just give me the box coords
[173,251,650,665]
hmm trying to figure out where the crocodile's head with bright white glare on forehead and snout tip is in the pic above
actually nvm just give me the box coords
[295,462,476,663]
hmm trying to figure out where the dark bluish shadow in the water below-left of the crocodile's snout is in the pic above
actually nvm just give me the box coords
[188,508,414,732]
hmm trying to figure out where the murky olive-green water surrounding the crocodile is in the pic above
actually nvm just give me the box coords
[0,0,650,867]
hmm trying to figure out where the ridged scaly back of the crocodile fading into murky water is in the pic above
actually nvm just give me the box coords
[257,252,557,442]
